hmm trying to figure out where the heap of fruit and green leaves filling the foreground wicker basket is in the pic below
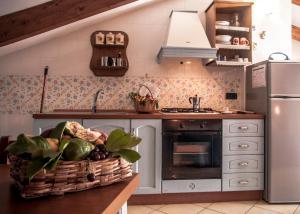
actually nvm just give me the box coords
[6,122,141,181]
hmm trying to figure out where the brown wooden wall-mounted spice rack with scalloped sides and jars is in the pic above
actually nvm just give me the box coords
[90,31,129,76]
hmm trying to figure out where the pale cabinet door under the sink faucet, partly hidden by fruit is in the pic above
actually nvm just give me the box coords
[83,119,130,134]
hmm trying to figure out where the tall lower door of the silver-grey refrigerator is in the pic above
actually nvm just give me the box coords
[266,98,300,203]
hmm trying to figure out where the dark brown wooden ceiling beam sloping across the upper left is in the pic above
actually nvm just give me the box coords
[0,0,136,47]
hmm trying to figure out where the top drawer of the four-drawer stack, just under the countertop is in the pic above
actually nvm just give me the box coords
[223,119,264,137]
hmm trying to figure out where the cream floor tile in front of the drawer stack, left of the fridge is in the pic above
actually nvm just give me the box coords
[208,202,255,214]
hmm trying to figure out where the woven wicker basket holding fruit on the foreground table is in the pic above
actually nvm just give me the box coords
[9,156,132,198]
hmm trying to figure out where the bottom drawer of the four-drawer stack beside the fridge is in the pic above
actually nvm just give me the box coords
[222,173,264,191]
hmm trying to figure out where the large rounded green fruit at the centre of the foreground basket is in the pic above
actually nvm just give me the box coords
[63,138,95,161]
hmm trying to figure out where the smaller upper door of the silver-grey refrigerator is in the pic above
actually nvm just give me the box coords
[268,63,300,97]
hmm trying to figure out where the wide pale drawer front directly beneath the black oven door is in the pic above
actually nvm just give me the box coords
[162,179,221,193]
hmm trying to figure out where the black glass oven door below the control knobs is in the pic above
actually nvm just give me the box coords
[162,132,222,179]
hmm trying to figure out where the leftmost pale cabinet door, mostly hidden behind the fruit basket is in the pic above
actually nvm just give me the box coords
[33,119,82,135]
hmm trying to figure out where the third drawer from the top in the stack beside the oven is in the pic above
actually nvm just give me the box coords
[223,155,264,173]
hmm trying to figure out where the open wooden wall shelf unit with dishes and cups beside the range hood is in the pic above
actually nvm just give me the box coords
[205,0,253,66]
